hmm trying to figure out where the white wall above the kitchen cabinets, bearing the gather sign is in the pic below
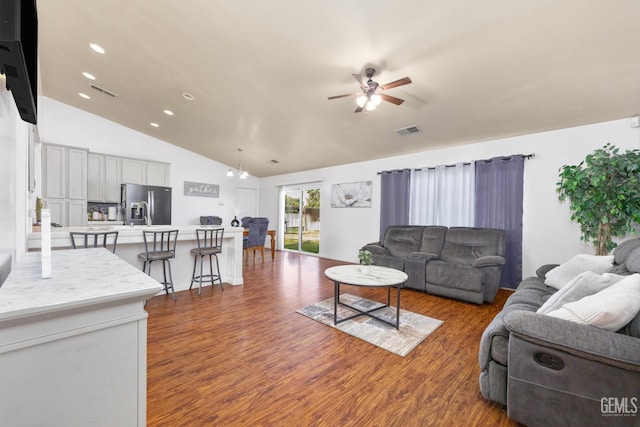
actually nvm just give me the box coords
[40,98,258,225]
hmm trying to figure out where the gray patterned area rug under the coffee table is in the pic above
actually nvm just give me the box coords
[296,294,443,357]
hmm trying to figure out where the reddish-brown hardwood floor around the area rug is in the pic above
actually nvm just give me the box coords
[146,252,517,426]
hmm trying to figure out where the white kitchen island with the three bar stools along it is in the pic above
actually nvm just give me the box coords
[27,225,244,292]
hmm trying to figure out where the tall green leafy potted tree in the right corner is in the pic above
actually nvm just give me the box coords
[556,143,640,255]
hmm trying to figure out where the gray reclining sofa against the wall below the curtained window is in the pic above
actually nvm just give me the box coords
[362,225,505,304]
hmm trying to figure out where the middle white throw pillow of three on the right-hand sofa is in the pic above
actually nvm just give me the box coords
[537,271,626,314]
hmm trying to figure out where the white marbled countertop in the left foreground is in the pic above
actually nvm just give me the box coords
[0,249,162,321]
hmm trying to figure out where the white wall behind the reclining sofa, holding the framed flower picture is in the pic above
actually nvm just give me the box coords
[260,119,640,276]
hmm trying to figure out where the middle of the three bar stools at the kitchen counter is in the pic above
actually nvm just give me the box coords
[138,229,178,300]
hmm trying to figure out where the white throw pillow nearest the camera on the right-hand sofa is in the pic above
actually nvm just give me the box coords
[547,274,640,331]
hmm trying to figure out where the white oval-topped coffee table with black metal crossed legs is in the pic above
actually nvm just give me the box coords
[324,264,408,329]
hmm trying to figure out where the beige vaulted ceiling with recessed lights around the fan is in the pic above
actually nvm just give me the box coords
[37,0,640,177]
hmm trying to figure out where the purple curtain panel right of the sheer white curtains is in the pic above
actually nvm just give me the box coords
[476,155,524,288]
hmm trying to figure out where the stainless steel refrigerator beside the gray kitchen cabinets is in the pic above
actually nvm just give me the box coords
[120,184,171,225]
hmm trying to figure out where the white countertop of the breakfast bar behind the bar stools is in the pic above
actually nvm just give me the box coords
[27,223,244,249]
